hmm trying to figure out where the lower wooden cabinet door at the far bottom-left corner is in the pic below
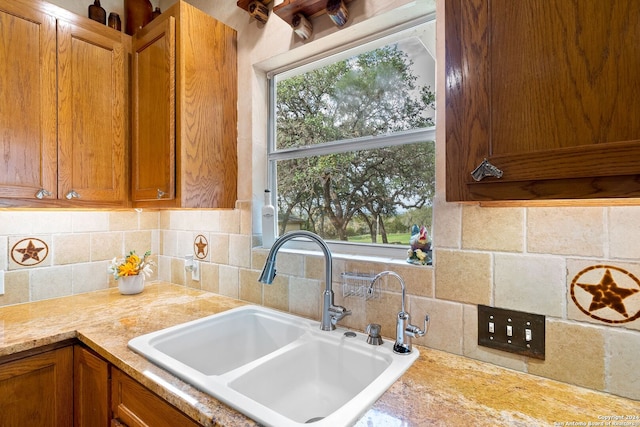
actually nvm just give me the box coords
[0,347,73,427]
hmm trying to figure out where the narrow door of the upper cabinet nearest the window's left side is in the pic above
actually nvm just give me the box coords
[131,17,176,202]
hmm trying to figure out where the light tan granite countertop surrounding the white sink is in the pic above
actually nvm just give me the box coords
[0,283,640,427]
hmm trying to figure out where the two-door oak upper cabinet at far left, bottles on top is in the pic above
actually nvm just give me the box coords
[0,0,131,207]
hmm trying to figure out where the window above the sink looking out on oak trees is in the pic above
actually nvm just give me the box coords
[268,18,435,258]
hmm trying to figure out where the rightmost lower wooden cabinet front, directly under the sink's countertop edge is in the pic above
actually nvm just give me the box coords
[111,368,198,427]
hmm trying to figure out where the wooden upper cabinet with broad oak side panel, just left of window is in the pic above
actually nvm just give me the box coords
[131,1,238,208]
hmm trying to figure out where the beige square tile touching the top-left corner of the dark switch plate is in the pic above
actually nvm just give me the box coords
[435,250,491,304]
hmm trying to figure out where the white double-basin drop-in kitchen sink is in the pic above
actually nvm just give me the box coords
[129,306,418,427]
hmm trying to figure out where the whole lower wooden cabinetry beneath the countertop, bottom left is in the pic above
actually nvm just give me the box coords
[0,345,199,427]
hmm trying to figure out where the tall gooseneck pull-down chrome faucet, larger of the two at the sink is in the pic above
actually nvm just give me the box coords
[258,230,351,331]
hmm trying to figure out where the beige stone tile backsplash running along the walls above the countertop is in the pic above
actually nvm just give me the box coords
[0,202,640,399]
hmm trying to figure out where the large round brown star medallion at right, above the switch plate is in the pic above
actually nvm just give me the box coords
[570,264,640,324]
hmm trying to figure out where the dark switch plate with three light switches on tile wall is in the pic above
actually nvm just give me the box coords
[478,305,545,360]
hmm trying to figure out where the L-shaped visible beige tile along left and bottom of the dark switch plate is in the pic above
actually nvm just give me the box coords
[463,305,527,372]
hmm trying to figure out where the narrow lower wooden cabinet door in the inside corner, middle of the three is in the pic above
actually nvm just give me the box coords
[73,345,111,427]
